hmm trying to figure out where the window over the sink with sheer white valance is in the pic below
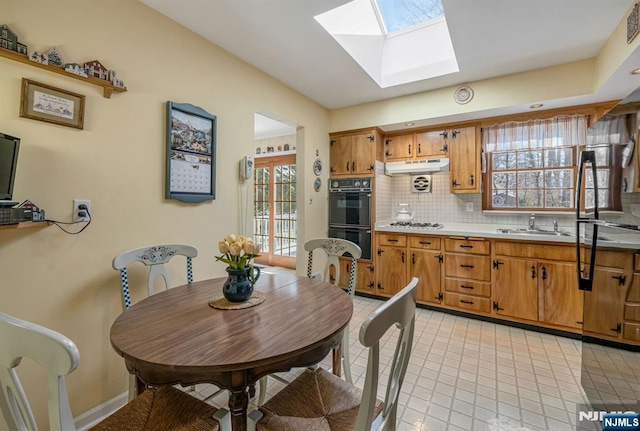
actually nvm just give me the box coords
[482,115,589,211]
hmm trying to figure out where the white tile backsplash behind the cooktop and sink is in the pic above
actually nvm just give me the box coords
[376,162,640,228]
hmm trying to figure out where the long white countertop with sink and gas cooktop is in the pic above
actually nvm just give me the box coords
[375,222,640,249]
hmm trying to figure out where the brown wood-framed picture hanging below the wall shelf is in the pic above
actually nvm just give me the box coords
[20,78,84,129]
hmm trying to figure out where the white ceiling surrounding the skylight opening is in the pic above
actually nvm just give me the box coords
[140,0,638,125]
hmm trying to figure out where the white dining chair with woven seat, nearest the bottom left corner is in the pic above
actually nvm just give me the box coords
[0,312,231,431]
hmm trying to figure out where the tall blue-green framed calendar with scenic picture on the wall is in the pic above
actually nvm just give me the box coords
[165,101,216,203]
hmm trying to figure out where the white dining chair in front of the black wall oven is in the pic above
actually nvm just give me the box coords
[258,238,362,406]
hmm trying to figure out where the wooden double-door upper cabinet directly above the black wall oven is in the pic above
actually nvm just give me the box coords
[329,130,382,177]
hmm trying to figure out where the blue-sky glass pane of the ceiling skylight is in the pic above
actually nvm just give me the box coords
[376,0,444,33]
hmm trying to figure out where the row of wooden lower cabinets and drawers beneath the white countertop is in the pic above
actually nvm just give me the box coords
[364,232,640,344]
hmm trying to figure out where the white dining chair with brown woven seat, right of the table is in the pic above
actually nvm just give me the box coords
[247,277,418,431]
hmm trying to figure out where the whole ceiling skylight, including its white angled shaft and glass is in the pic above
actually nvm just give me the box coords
[315,0,459,88]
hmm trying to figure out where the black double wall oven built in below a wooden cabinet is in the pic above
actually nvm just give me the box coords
[329,178,373,259]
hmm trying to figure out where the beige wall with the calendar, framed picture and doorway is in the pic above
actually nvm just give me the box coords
[0,0,328,429]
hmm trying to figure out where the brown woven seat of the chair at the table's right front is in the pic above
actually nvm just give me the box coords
[257,368,383,431]
